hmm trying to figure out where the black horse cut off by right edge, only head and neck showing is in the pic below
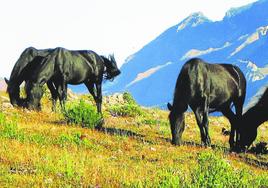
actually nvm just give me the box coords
[239,88,268,150]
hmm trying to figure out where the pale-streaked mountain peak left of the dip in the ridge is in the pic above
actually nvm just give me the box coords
[177,12,210,31]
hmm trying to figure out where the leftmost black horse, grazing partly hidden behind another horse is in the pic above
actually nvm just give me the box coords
[5,47,57,107]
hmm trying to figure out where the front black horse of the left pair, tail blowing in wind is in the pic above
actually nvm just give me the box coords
[27,48,120,113]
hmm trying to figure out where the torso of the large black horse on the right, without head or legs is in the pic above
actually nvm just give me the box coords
[175,58,245,108]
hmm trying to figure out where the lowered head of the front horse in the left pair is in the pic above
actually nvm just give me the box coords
[26,83,43,111]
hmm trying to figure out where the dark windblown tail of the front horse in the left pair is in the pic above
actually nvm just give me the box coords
[101,55,121,80]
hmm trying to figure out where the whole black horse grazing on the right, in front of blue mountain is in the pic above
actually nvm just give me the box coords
[168,58,246,149]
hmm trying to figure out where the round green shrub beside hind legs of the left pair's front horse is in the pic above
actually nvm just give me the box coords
[63,100,102,128]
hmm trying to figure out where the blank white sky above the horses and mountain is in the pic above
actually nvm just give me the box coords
[0,0,256,77]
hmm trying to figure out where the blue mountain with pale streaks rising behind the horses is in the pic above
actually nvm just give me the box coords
[105,0,268,106]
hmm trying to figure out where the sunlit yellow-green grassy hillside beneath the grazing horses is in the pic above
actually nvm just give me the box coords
[0,92,268,187]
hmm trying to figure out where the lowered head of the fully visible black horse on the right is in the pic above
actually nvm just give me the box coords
[167,103,185,145]
